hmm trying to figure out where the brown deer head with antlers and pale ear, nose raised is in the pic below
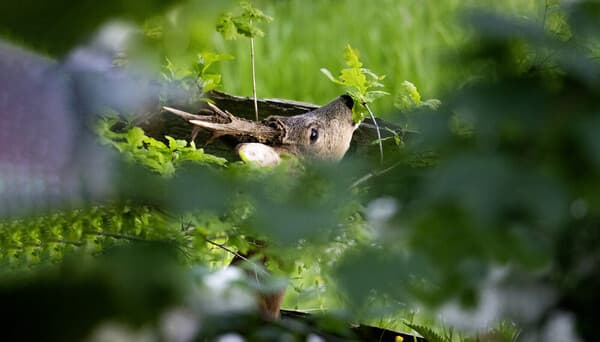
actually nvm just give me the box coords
[164,95,358,165]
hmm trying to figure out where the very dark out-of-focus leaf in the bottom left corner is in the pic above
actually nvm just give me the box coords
[0,244,189,341]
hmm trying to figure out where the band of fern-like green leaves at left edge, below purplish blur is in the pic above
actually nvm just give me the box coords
[0,205,177,274]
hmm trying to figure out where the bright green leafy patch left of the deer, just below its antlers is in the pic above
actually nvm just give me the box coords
[98,120,227,176]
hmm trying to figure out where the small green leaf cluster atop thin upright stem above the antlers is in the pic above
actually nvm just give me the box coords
[216,1,273,40]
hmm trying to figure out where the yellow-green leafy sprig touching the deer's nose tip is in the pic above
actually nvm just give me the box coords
[321,45,389,122]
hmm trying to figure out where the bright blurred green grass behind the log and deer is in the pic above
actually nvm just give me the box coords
[171,0,545,115]
